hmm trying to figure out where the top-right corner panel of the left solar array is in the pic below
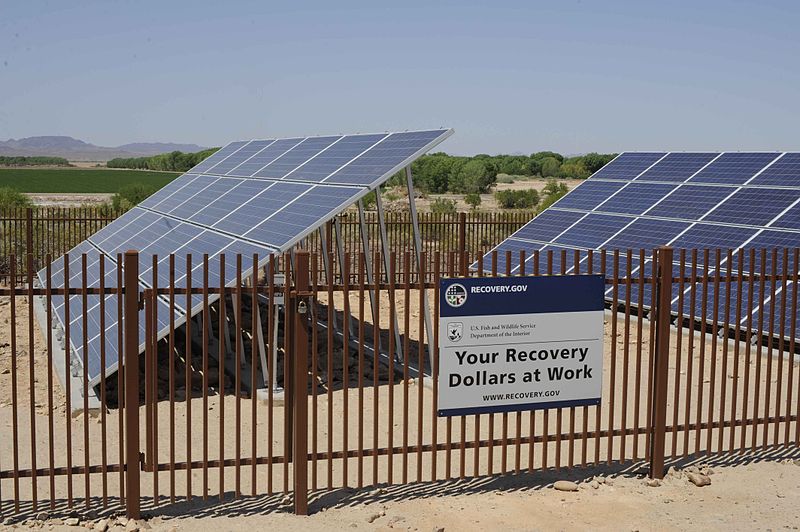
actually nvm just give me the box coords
[325,131,447,186]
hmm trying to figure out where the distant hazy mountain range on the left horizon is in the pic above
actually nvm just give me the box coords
[0,136,205,162]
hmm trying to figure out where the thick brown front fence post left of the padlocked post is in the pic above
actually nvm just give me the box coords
[123,251,140,519]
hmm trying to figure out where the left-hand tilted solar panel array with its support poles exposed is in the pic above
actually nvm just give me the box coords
[39,129,453,384]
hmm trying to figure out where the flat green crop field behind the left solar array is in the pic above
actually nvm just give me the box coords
[0,168,180,194]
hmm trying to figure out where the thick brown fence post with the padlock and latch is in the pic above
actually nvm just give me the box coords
[290,250,310,515]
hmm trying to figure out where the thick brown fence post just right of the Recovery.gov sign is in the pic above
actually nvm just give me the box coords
[640,246,672,478]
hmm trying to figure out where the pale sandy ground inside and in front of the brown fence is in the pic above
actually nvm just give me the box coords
[0,291,800,530]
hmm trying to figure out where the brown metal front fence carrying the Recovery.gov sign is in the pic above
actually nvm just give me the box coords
[0,248,800,516]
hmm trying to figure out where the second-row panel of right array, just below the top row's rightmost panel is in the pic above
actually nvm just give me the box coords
[703,188,800,225]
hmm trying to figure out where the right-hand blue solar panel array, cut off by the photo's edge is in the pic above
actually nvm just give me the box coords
[483,152,800,336]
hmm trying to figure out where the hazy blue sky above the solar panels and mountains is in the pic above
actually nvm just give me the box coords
[0,0,800,154]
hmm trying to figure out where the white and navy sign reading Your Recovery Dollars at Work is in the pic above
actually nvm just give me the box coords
[438,275,605,416]
